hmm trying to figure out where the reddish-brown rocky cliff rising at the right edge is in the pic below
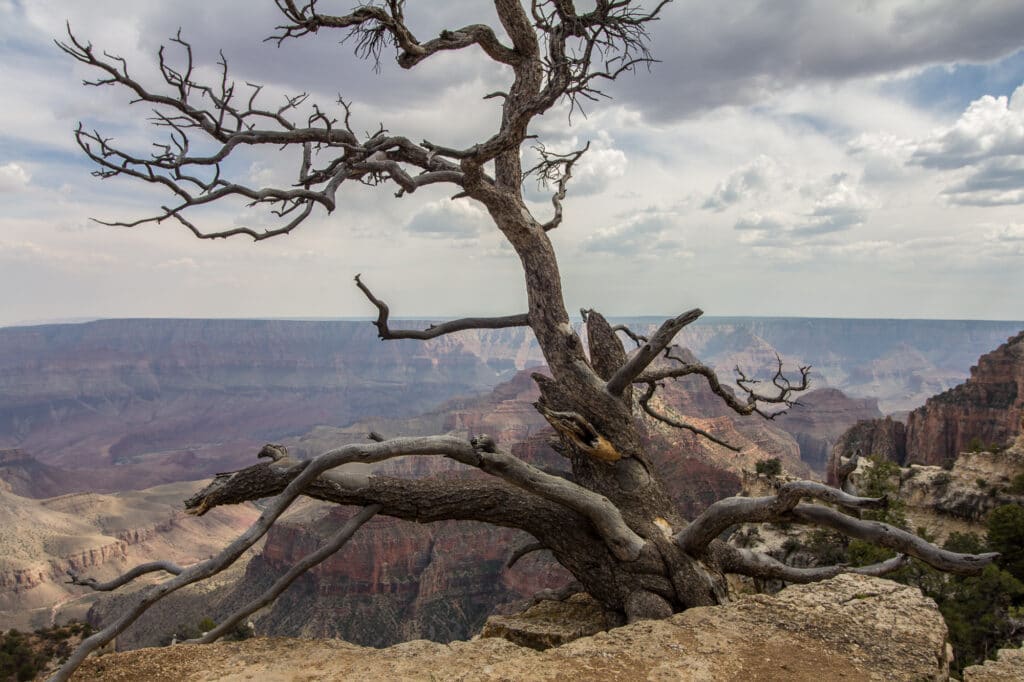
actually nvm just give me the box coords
[906,332,1024,465]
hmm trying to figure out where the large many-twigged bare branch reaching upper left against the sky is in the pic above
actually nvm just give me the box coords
[57,28,463,240]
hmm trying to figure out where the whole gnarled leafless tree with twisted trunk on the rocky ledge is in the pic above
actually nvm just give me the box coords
[51,0,992,679]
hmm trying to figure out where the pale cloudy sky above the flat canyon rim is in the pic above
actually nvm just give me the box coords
[0,0,1024,326]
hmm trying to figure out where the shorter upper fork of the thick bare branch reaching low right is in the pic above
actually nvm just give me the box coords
[675,480,888,554]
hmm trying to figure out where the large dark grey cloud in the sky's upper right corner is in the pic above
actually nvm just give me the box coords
[608,0,1024,121]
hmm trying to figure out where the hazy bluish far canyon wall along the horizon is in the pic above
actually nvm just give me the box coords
[0,317,1020,495]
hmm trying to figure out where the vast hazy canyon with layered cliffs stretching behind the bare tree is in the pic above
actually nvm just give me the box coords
[0,318,1021,648]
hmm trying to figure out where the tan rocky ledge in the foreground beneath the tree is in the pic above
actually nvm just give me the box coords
[74,576,949,682]
